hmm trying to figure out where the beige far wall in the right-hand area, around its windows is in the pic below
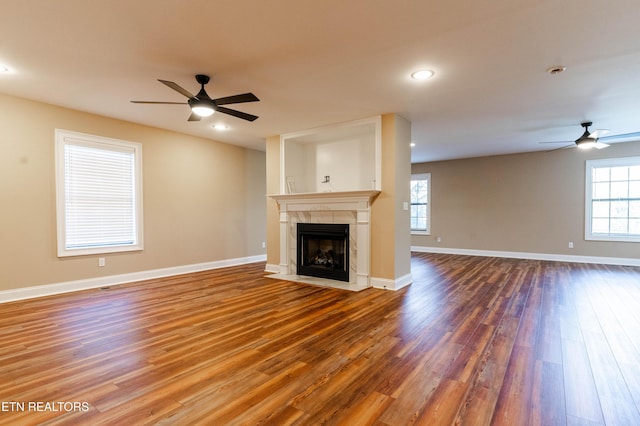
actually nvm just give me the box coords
[412,142,640,258]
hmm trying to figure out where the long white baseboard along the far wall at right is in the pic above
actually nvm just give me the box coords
[411,246,640,266]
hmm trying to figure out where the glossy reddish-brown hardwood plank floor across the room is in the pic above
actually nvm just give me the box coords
[0,253,640,425]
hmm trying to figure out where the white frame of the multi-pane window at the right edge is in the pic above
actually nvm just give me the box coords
[584,156,640,242]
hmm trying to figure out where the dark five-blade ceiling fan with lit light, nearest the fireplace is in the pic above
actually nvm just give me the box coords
[131,74,260,121]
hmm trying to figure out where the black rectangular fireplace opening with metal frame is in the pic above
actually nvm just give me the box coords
[296,223,349,282]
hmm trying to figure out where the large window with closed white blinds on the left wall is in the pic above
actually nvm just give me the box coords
[55,129,142,257]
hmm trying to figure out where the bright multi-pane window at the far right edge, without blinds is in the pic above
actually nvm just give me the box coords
[585,157,640,242]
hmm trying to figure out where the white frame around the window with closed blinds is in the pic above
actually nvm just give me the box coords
[54,129,144,257]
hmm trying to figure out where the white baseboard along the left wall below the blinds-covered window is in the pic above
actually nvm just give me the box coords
[0,255,267,303]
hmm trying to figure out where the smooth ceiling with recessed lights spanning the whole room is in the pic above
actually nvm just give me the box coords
[0,0,640,162]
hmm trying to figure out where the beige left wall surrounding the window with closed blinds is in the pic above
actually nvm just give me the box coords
[0,95,266,290]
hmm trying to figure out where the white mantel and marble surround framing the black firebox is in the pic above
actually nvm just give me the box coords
[270,190,380,291]
